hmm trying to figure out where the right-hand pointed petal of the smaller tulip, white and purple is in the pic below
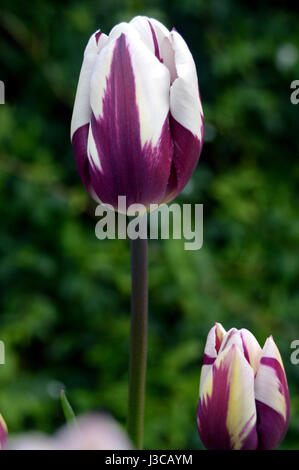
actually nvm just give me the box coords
[255,336,290,449]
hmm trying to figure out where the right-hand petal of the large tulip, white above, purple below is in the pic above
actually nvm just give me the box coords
[165,31,203,202]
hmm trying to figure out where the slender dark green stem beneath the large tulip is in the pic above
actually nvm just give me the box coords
[128,238,148,449]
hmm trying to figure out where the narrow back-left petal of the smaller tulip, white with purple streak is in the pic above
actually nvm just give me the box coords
[199,323,226,390]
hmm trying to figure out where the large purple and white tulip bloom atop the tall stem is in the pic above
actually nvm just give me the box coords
[71,16,203,208]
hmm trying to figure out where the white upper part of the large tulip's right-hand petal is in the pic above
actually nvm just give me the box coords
[170,31,203,140]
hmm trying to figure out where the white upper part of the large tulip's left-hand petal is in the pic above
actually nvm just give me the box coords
[71,31,107,138]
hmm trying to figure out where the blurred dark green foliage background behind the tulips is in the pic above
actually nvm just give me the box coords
[0,0,299,449]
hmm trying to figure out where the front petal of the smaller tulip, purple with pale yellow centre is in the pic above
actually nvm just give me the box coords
[197,344,257,450]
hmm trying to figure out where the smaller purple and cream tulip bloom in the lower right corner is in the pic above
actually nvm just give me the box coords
[197,323,290,450]
